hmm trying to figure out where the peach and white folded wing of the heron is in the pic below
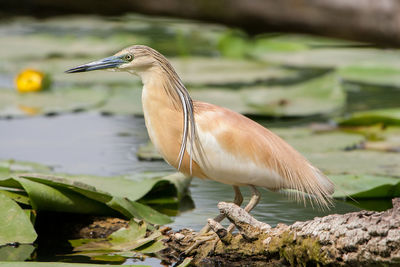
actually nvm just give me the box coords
[194,102,334,208]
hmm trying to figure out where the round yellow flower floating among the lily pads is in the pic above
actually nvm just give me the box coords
[15,69,50,93]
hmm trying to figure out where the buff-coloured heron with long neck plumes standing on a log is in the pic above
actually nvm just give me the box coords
[66,45,334,232]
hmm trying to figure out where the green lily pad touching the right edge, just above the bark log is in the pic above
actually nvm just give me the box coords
[329,175,400,199]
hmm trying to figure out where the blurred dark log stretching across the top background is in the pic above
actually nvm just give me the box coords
[0,0,400,46]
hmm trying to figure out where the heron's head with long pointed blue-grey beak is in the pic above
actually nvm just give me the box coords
[66,45,164,76]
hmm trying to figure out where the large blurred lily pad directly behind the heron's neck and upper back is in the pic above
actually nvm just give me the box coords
[190,74,346,116]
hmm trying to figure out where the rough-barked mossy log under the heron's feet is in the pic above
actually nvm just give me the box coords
[164,198,400,266]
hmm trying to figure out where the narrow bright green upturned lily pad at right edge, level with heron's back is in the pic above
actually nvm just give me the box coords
[338,108,400,126]
